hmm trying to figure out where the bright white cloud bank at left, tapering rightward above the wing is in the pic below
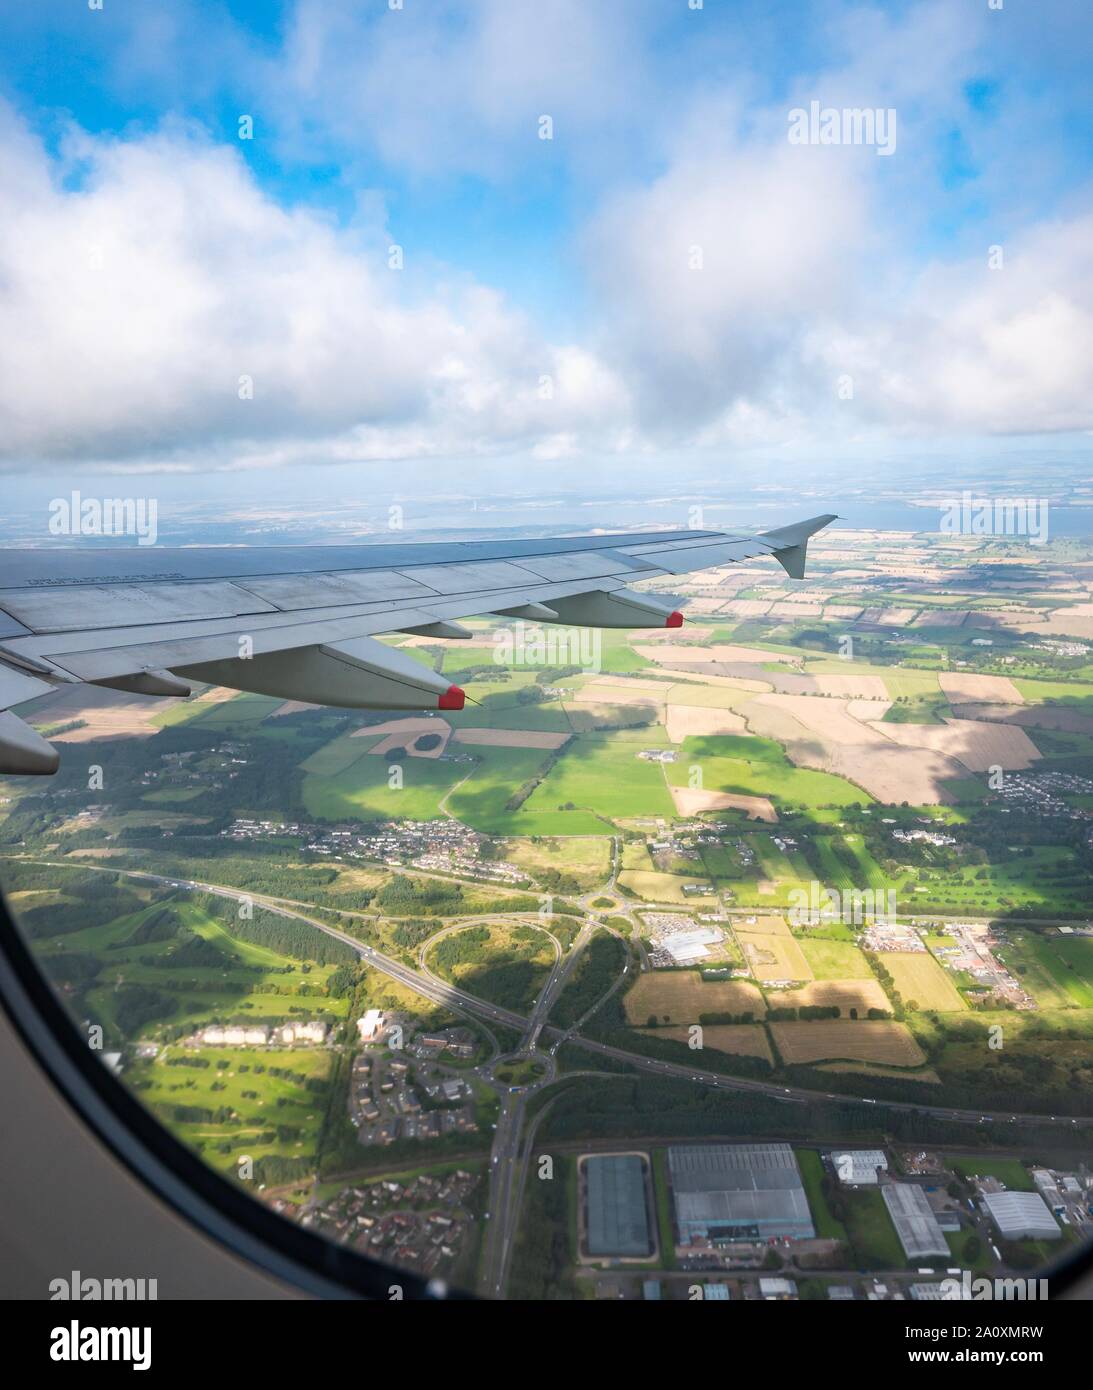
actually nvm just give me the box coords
[0,104,626,467]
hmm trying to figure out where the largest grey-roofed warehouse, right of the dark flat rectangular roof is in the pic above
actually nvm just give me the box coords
[667,1144,816,1245]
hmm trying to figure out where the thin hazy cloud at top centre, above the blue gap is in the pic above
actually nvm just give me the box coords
[279,0,656,177]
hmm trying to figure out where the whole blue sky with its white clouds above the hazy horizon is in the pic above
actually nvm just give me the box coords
[0,0,1093,500]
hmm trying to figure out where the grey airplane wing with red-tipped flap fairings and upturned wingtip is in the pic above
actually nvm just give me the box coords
[0,516,836,773]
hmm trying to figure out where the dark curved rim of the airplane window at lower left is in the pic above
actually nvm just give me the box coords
[0,884,464,1302]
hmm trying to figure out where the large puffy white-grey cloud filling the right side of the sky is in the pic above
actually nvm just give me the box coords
[575,3,1093,449]
